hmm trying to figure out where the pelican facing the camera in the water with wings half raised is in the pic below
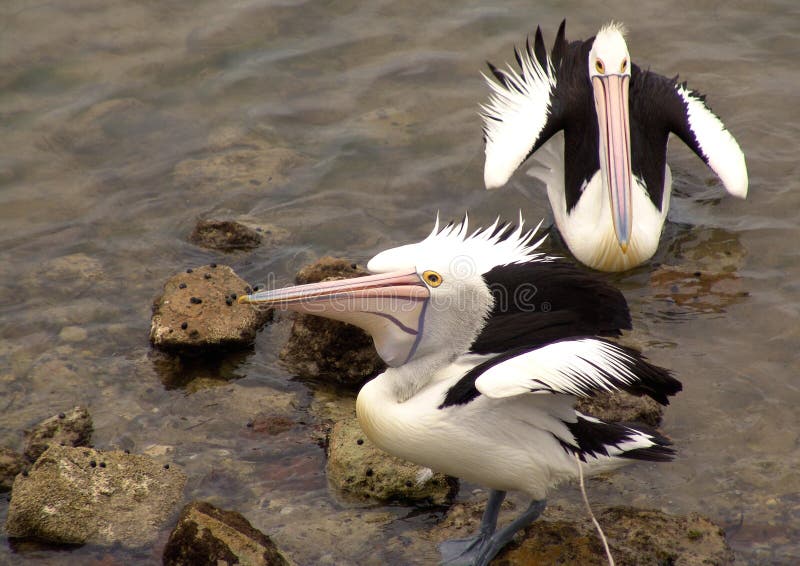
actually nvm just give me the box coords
[481,21,748,271]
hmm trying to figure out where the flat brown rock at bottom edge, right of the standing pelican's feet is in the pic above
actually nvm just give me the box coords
[504,507,733,566]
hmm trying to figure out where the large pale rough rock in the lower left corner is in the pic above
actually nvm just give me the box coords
[6,445,186,547]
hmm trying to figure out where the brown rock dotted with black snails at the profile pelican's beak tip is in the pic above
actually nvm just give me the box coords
[150,264,272,351]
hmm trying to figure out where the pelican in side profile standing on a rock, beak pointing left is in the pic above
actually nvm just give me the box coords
[239,217,681,565]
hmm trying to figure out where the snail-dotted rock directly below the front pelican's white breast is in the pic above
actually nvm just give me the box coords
[326,417,458,505]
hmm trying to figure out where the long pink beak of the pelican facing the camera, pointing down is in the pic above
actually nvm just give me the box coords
[592,75,633,253]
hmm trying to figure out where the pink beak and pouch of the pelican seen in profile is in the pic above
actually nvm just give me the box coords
[239,271,430,366]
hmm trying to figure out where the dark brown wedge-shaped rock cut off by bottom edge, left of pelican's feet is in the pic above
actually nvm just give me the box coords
[163,501,289,566]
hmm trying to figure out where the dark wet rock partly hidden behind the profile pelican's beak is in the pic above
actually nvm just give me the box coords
[280,257,386,387]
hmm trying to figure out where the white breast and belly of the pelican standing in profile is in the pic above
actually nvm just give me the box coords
[356,374,600,499]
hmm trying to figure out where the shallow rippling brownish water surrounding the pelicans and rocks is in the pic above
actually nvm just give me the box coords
[0,0,800,564]
